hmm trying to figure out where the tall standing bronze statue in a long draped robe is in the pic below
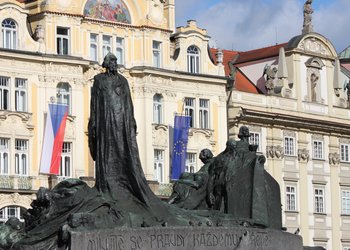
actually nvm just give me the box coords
[88,53,152,204]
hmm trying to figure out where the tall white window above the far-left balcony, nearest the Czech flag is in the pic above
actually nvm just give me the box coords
[15,139,28,175]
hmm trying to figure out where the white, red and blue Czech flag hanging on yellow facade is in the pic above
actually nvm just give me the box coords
[40,104,68,175]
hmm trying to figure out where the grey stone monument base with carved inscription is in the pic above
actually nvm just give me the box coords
[70,226,303,250]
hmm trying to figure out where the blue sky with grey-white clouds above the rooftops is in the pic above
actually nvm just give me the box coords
[175,0,350,52]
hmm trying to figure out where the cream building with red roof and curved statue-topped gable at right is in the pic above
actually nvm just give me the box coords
[211,28,350,250]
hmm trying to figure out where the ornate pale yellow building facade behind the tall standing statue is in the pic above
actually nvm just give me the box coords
[0,0,227,222]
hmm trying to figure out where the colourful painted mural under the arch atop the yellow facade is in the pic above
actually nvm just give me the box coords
[84,0,131,23]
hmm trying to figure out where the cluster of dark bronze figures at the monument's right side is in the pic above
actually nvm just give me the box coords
[169,126,282,229]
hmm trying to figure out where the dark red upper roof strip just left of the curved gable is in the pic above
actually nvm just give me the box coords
[235,43,287,64]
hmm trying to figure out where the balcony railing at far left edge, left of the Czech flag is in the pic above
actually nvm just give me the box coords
[0,175,33,190]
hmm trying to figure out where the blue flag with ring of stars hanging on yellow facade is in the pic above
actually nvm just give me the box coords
[171,115,191,180]
